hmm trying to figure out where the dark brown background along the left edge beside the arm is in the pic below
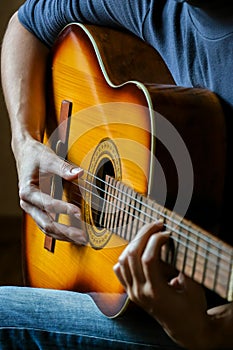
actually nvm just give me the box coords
[0,0,24,285]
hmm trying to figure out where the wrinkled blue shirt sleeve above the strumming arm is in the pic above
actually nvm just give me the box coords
[18,0,151,47]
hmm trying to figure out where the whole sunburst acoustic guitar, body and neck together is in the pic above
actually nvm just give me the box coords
[23,24,230,317]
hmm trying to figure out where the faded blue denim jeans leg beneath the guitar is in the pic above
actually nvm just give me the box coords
[0,287,179,350]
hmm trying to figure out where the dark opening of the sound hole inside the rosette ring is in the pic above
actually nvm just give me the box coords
[91,158,115,229]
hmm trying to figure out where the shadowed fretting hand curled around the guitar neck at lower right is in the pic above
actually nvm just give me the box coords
[114,222,227,350]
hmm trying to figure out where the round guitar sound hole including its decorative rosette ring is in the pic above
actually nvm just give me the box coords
[83,138,122,249]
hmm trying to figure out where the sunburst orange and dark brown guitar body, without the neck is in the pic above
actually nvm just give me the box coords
[24,24,225,317]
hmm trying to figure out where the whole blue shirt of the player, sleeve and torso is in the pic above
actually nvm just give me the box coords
[18,0,233,108]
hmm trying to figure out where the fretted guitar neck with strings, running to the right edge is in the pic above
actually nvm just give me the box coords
[104,176,233,301]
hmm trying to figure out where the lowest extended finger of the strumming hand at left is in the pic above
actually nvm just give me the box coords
[23,202,87,245]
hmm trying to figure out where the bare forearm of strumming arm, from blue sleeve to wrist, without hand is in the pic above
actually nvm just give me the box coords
[1,14,48,156]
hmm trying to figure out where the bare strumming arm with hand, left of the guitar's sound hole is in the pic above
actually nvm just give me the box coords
[1,14,85,243]
